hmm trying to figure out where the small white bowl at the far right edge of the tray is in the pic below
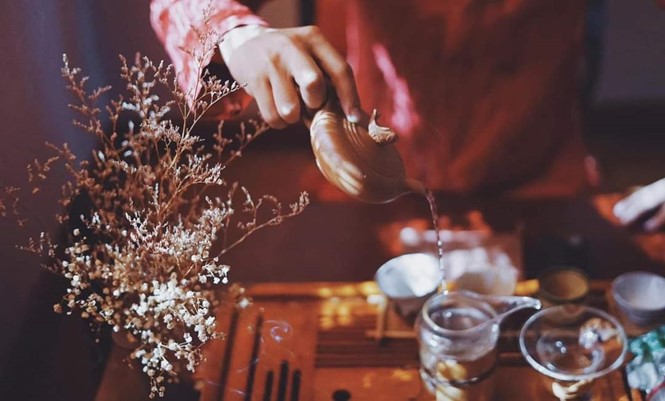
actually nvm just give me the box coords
[612,272,665,324]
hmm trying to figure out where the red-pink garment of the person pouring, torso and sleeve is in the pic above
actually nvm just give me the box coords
[152,0,586,196]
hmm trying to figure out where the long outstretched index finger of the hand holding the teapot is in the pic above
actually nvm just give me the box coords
[309,28,360,122]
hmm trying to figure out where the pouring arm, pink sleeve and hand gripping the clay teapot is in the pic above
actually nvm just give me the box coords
[151,0,361,128]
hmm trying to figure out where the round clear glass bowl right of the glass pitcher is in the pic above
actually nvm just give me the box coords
[519,304,628,400]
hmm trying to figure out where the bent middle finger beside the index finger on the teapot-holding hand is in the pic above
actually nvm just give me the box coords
[289,55,326,109]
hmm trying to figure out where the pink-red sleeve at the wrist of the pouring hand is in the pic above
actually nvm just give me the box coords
[150,0,267,115]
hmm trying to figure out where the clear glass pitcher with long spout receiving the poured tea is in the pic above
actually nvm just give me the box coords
[416,291,540,401]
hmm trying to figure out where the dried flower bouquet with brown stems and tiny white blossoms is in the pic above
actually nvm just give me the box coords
[0,51,308,396]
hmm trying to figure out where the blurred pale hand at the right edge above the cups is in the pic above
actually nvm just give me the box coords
[614,178,665,231]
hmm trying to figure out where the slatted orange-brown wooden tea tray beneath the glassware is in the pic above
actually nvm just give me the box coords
[196,281,640,401]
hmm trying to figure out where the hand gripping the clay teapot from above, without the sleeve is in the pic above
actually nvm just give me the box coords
[220,26,361,128]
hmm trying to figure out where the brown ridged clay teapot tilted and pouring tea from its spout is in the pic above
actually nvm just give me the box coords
[305,98,426,203]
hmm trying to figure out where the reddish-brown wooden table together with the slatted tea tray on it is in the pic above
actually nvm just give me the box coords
[88,188,665,401]
